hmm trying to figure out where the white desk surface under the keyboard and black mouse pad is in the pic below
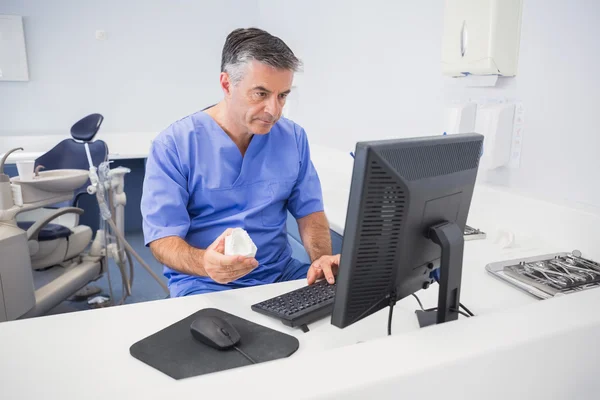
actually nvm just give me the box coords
[0,242,600,399]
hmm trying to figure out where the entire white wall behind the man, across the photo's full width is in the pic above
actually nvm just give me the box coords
[0,0,600,212]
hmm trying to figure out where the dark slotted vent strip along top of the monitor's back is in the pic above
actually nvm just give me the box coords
[378,141,481,181]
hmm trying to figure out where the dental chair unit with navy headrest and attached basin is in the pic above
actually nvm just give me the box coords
[0,114,108,322]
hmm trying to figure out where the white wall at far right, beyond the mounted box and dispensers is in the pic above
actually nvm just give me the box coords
[445,0,600,213]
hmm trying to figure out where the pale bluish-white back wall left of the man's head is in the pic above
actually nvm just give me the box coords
[0,0,258,134]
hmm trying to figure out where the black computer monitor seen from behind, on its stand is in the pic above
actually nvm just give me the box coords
[331,134,483,328]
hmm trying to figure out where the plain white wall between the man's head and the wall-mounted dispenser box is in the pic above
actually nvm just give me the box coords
[259,0,444,151]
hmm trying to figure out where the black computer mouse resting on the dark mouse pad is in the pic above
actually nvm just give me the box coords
[190,316,241,350]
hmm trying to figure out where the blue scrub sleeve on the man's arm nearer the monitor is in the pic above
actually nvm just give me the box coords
[288,125,323,219]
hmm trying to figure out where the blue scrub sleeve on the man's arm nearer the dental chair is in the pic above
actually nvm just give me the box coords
[141,140,190,246]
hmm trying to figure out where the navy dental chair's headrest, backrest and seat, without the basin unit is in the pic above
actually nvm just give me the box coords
[17,114,108,270]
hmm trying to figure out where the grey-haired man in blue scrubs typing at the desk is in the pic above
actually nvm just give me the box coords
[141,28,340,297]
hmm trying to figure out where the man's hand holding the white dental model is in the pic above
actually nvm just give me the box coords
[204,228,258,284]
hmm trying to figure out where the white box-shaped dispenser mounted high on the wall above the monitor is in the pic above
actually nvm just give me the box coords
[442,0,523,76]
